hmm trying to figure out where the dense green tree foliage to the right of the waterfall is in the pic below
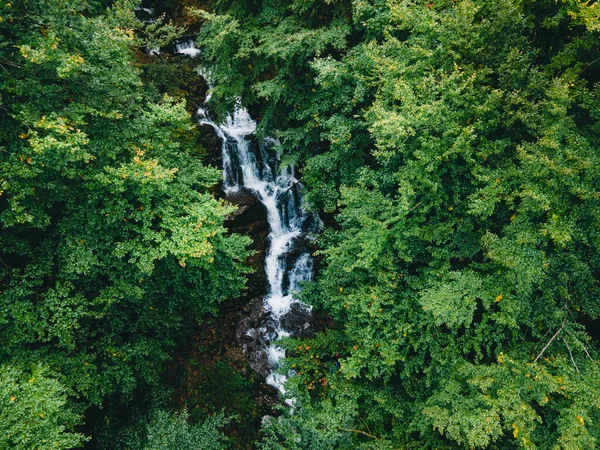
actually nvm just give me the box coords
[200,0,600,449]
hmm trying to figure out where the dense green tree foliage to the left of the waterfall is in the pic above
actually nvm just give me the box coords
[0,0,247,442]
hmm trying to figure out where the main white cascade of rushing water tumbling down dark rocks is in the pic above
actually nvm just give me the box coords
[198,108,318,393]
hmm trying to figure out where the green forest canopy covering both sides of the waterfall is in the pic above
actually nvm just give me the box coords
[0,0,600,450]
